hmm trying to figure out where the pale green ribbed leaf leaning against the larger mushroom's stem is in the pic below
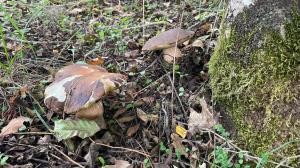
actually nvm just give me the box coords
[54,120,101,141]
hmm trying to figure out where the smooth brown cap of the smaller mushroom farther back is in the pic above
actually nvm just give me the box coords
[142,28,194,51]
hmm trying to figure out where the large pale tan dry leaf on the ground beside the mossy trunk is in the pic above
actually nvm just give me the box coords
[188,98,216,135]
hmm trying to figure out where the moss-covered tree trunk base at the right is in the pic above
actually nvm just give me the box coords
[209,0,300,166]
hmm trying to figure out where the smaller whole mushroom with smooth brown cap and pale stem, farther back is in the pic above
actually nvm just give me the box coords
[142,28,194,63]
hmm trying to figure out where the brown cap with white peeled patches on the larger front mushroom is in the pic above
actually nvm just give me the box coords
[44,64,127,114]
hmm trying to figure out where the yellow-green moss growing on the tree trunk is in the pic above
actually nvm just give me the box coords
[209,8,300,165]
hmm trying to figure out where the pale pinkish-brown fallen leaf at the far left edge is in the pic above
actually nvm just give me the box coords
[0,116,31,139]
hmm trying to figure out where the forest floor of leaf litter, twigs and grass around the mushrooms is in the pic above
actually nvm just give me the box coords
[0,0,259,168]
